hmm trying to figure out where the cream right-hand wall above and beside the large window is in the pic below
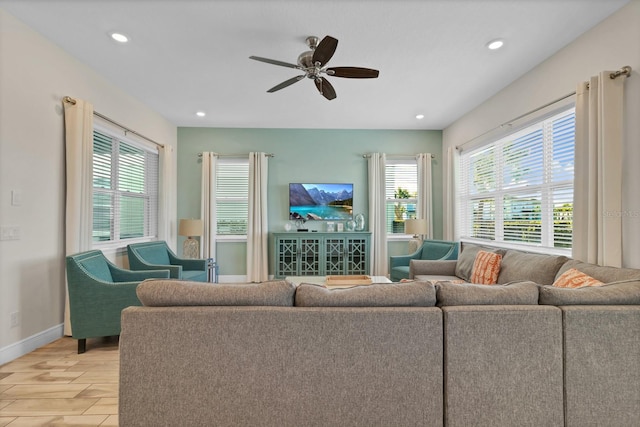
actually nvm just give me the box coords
[443,0,640,268]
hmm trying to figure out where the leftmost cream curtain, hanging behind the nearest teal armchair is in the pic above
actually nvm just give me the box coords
[63,99,93,335]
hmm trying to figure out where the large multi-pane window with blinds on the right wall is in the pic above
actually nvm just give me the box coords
[459,108,575,249]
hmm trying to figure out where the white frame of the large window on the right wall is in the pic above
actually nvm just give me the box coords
[456,107,575,256]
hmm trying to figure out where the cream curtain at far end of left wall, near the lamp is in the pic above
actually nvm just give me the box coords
[158,145,176,249]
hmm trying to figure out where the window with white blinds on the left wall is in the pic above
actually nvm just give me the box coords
[93,129,158,245]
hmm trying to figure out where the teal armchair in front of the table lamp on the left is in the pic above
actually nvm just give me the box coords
[127,240,209,282]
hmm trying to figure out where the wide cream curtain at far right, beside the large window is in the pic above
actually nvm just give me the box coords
[572,71,625,267]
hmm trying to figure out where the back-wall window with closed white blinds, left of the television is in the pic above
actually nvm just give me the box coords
[216,158,249,235]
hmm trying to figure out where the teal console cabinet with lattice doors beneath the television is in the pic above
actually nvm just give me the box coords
[273,232,371,279]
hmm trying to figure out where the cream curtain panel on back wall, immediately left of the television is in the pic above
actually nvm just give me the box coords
[247,152,269,282]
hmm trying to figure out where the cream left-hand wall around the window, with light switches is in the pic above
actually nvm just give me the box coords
[0,9,177,364]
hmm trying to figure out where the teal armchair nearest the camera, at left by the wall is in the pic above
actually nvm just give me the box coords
[66,250,169,353]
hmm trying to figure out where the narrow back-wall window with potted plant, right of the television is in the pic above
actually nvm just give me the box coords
[385,159,418,234]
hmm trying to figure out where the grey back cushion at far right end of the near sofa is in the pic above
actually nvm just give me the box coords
[539,279,640,306]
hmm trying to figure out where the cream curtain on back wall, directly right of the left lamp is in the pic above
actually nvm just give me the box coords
[200,151,218,259]
